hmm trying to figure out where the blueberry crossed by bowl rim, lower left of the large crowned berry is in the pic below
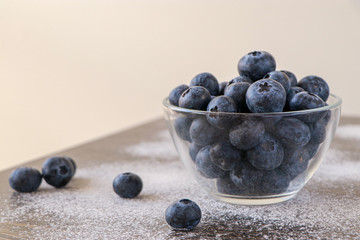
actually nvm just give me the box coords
[206,95,237,129]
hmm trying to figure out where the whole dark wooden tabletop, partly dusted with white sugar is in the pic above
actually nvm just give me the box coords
[0,117,360,239]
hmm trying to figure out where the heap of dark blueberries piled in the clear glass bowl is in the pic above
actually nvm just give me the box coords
[168,51,331,196]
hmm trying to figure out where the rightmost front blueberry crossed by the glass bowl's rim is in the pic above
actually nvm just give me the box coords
[289,92,326,123]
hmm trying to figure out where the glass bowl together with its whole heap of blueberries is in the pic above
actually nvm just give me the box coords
[163,51,342,205]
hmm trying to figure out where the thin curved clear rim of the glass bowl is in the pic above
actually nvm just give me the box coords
[163,93,342,117]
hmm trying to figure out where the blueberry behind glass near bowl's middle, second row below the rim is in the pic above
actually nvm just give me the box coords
[247,133,284,170]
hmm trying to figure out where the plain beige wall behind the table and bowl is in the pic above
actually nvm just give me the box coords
[0,0,360,169]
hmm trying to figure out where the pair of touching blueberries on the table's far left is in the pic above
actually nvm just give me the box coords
[9,156,76,192]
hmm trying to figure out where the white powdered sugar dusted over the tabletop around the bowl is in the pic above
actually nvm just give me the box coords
[0,130,360,239]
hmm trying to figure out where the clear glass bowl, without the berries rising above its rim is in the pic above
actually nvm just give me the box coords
[163,94,342,205]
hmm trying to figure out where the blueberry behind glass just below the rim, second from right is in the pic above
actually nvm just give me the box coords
[274,118,311,147]
